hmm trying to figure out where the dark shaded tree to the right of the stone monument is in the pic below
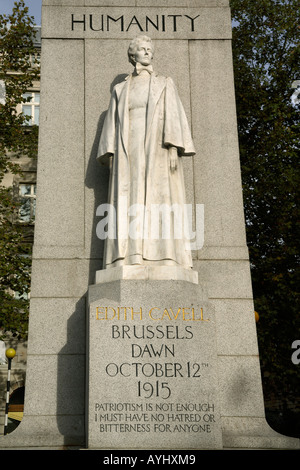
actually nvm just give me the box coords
[230,0,300,436]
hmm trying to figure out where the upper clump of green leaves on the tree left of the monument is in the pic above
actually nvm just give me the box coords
[0,0,39,175]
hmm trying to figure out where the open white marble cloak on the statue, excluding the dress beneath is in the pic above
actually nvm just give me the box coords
[97,73,195,267]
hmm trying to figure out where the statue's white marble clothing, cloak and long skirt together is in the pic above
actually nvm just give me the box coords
[97,73,195,268]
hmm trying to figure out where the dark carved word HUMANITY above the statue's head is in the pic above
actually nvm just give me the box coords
[71,13,200,32]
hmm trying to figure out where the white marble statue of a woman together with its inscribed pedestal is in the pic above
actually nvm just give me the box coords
[86,35,222,449]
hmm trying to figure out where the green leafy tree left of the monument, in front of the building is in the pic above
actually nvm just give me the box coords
[0,0,39,338]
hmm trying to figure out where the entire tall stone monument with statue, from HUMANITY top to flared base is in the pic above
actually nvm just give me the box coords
[0,0,299,449]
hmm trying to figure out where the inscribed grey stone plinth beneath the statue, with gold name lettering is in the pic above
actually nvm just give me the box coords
[86,280,222,449]
